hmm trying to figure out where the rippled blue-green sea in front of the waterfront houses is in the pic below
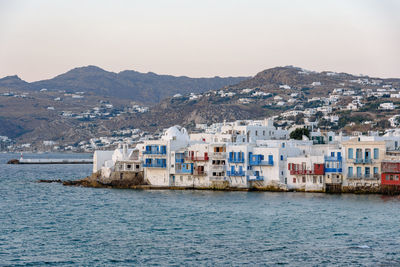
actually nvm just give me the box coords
[0,154,400,266]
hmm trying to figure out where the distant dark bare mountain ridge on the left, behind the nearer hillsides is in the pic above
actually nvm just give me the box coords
[0,66,248,103]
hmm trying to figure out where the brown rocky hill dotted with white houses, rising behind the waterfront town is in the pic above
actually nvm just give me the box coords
[108,66,400,133]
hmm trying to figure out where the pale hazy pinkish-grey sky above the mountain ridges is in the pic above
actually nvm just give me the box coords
[0,0,400,82]
